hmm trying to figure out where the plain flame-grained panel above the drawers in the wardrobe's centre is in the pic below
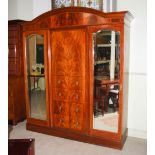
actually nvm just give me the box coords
[51,29,85,76]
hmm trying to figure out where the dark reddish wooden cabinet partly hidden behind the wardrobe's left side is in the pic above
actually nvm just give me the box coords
[8,20,26,124]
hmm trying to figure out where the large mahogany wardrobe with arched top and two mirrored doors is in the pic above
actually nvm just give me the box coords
[23,7,132,149]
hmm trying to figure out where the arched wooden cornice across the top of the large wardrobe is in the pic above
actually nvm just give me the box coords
[23,7,127,31]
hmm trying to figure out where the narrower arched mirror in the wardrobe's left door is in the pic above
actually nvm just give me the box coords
[26,35,46,120]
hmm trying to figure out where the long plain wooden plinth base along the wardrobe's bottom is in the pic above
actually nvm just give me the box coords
[26,124,127,150]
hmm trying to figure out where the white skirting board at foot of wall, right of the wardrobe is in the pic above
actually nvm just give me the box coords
[128,128,147,139]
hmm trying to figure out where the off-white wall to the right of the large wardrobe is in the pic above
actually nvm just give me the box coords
[117,0,147,138]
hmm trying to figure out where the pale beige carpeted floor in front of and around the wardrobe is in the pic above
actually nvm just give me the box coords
[10,121,147,155]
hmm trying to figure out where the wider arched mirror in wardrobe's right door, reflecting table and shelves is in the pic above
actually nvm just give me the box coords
[93,30,120,132]
